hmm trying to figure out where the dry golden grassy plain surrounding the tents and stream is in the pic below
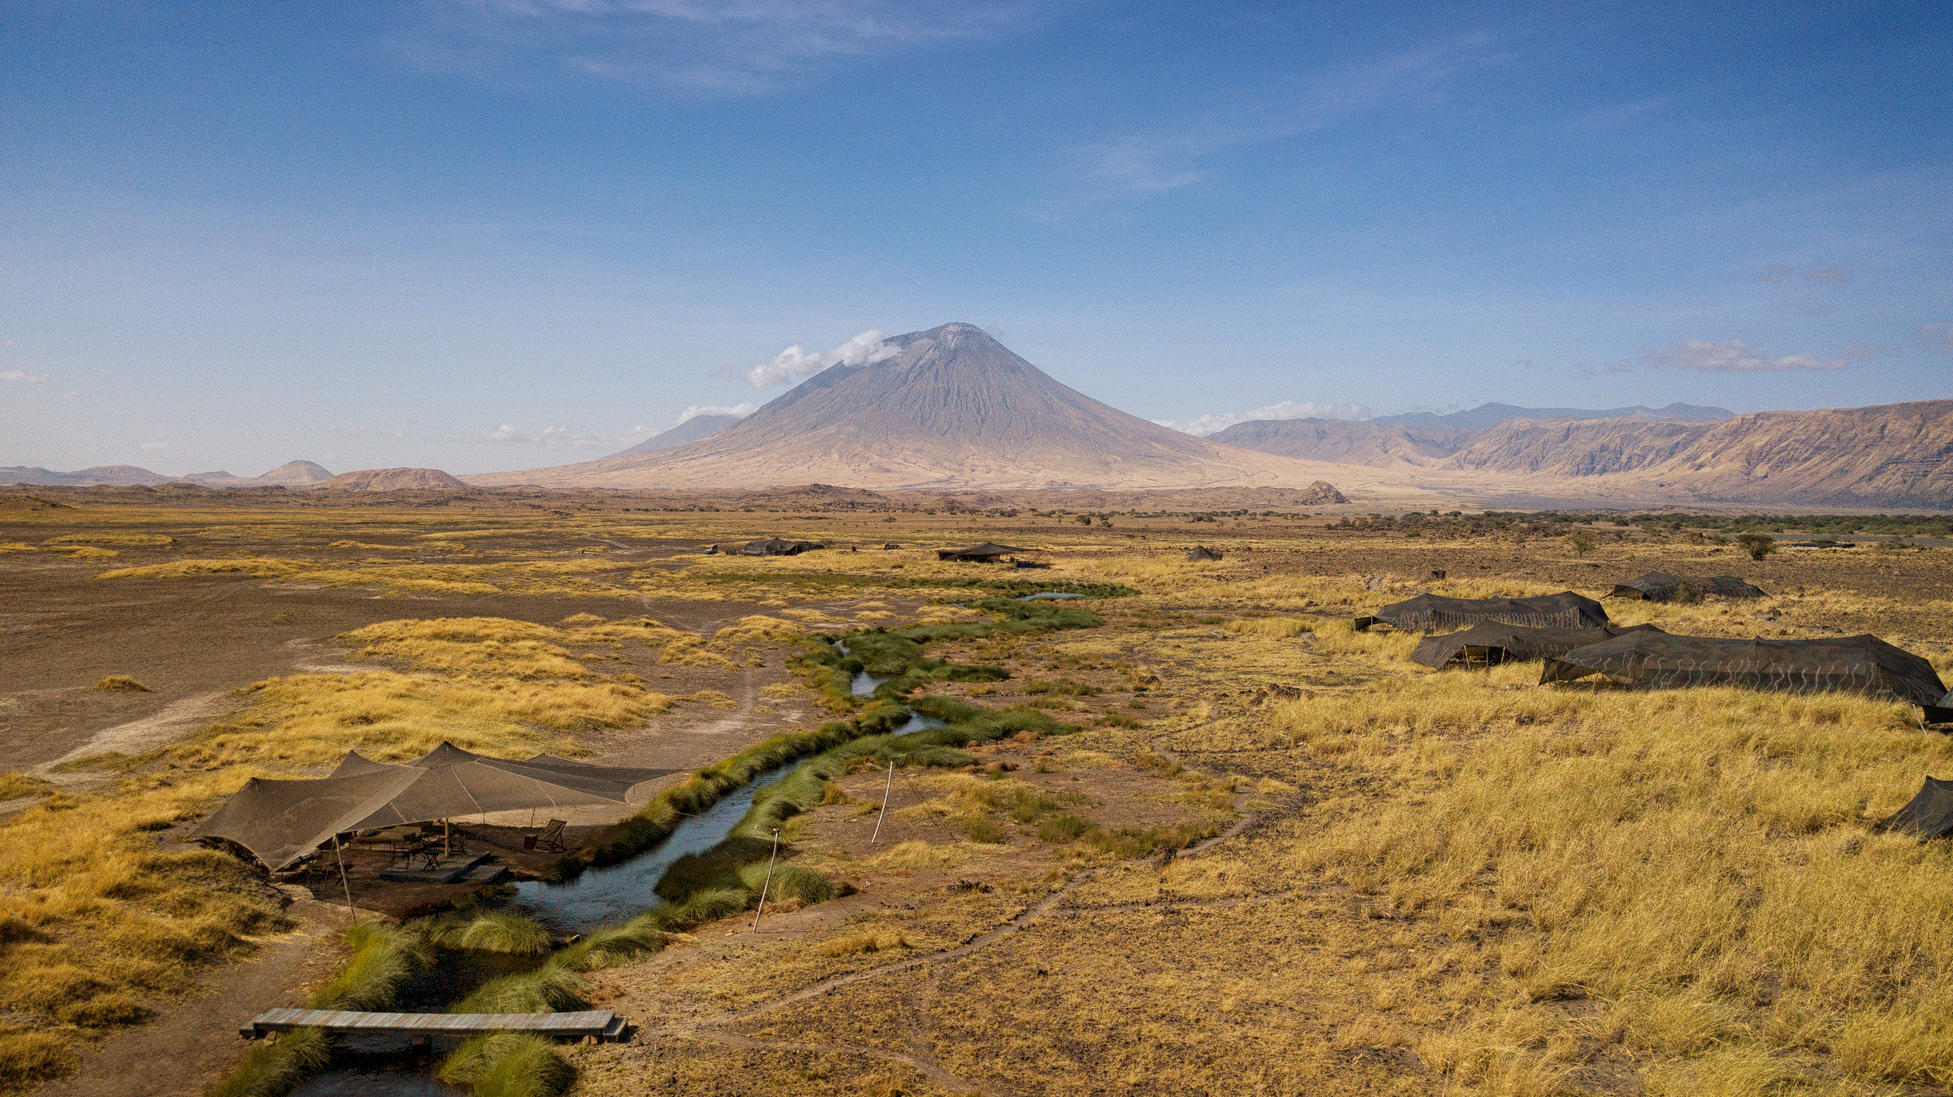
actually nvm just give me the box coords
[0,492,1953,1097]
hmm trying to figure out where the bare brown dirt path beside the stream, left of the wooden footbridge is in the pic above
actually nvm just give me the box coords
[33,900,363,1097]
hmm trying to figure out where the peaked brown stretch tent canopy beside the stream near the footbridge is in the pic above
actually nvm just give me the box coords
[191,744,674,869]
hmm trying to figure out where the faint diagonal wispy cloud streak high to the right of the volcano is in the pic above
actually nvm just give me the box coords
[1027,33,1508,221]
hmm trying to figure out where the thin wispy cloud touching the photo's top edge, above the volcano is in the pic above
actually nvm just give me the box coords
[395,0,1066,100]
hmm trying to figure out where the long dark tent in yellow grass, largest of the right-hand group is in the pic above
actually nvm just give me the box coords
[1539,632,1947,705]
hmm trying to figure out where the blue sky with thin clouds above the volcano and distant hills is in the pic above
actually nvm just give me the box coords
[0,0,1953,474]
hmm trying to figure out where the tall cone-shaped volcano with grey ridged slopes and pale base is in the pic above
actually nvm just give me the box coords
[471,324,1351,488]
